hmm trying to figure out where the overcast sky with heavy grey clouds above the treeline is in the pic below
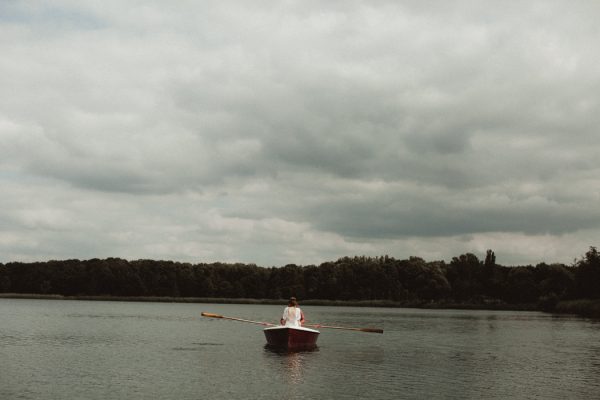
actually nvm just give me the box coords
[0,0,600,266]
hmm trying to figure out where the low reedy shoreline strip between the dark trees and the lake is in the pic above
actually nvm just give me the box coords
[0,293,600,319]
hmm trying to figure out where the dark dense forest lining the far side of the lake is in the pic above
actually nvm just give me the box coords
[0,247,600,310]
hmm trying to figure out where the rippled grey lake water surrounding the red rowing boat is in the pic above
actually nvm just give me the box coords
[0,299,600,400]
